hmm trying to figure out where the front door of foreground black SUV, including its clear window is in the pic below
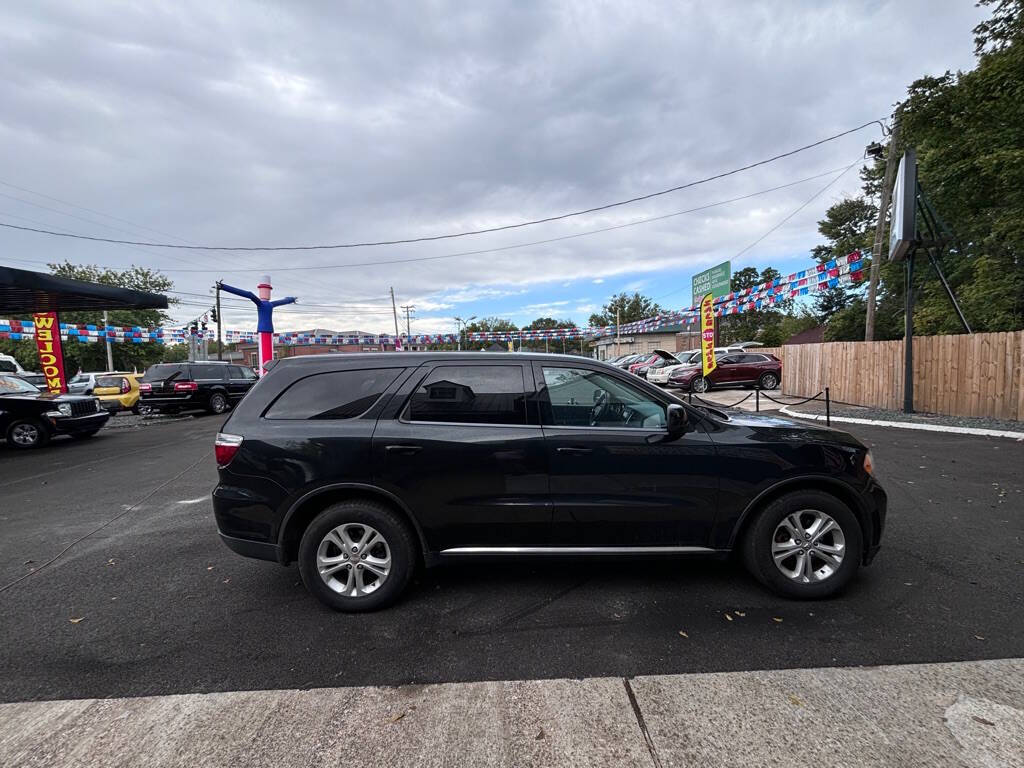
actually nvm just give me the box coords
[534,362,719,548]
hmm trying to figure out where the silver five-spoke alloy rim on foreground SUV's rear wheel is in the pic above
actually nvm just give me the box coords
[316,522,391,597]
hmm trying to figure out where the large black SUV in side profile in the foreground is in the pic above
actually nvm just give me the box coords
[213,352,886,610]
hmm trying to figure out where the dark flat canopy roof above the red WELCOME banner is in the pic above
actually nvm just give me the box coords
[0,266,167,313]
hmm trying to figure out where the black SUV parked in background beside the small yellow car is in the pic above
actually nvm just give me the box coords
[138,360,256,414]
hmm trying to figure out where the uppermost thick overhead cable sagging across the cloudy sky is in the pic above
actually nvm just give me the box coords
[0,120,880,251]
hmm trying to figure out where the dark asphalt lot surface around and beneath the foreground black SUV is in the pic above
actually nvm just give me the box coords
[0,417,1024,701]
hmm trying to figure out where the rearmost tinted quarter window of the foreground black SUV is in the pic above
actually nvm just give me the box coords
[266,368,404,419]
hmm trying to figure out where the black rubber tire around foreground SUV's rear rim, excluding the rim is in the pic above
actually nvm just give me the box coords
[298,501,418,612]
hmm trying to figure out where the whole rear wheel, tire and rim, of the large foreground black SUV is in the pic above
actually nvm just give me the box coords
[298,501,416,611]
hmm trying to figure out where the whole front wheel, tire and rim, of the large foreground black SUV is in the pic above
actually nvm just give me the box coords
[741,490,863,600]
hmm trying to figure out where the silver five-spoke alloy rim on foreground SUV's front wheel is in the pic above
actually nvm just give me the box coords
[771,509,846,584]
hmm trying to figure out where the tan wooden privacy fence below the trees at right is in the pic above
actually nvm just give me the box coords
[774,331,1024,421]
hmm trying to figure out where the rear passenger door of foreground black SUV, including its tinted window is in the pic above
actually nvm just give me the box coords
[373,361,551,552]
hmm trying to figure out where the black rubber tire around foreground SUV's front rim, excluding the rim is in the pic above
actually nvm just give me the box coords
[740,490,863,600]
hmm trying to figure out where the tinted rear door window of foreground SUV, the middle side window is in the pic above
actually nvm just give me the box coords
[408,366,526,424]
